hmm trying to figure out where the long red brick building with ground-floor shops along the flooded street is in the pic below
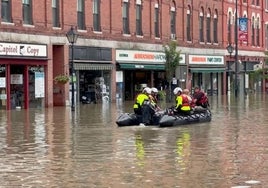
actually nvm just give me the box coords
[0,0,268,109]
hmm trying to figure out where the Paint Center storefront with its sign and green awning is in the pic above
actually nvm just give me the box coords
[189,55,226,95]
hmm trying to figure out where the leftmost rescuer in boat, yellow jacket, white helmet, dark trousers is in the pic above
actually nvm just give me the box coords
[133,87,155,125]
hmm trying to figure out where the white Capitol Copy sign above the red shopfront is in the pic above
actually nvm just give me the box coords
[0,43,47,57]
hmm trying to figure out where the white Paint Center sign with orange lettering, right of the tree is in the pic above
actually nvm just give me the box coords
[189,55,224,65]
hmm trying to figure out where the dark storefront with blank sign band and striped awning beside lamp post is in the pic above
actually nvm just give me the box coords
[70,46,114,103]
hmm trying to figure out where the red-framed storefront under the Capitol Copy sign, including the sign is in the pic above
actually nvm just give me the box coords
[0,43,47,110]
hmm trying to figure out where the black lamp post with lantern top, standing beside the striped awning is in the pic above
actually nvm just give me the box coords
[66,27,78,111]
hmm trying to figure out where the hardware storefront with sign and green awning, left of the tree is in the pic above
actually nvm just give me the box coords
[116,50,167,100]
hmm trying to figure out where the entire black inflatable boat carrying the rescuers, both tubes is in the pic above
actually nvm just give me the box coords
[116,109,212,127]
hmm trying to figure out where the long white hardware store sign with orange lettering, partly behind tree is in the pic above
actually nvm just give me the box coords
[116,50,185,64]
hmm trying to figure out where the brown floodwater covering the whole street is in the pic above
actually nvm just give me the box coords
[0,95,268,188]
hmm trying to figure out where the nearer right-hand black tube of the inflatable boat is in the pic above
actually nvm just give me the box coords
[159,109,212,127]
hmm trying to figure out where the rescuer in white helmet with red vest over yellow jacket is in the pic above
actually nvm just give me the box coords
[173,87,191,115]
